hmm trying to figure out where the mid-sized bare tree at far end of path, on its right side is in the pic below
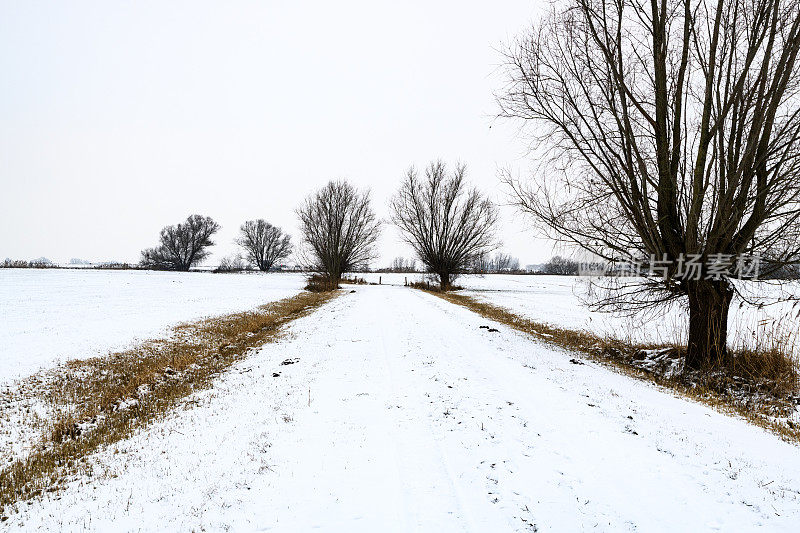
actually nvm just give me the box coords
[391,161,497,290]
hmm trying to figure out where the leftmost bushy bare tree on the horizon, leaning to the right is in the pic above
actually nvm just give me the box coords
[141,215,219,271]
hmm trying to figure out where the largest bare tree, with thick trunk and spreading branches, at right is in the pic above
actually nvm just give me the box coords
[498,0,800,368]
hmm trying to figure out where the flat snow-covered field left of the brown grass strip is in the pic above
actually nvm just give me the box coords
[0,269,305,383]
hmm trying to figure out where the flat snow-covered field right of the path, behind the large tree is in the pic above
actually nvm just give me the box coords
[359,274,800,348]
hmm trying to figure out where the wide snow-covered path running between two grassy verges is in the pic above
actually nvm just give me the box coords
[9,286,800,532]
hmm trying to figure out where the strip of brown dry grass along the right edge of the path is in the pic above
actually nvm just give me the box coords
[430,291,800,443]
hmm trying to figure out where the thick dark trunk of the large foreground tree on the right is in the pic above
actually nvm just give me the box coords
[686,280,733,370]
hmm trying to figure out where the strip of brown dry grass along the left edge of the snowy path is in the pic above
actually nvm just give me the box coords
[0,292,338,514]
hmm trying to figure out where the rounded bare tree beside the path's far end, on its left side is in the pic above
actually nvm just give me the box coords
[297,181,380,287]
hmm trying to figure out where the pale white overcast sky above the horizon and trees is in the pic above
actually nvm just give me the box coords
[0,0,552,266]
